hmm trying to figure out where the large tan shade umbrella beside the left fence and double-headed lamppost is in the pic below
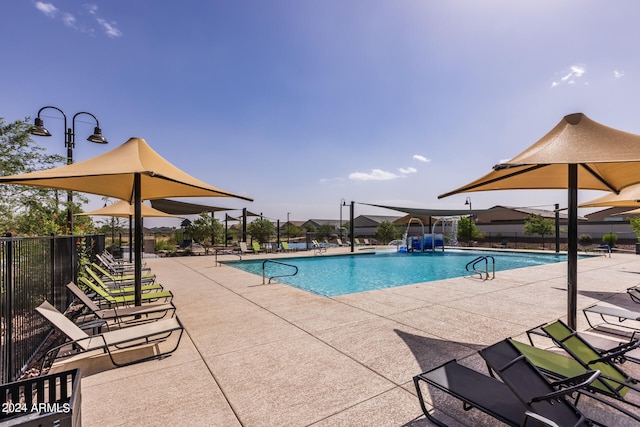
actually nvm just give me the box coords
[0,138,251,305]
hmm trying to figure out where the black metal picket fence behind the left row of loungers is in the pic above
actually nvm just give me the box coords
[0,235,105,384]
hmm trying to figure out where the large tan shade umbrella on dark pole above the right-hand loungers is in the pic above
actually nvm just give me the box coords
[438,113,640,329]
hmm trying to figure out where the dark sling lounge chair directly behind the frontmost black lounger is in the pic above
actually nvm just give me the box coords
[479,339,640,426]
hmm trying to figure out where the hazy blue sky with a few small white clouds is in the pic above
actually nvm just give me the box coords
[0,0,640,225]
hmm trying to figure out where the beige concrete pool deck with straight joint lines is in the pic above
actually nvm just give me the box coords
[82,248,640,427]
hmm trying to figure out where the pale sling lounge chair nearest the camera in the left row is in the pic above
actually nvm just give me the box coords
[36,301,183,372]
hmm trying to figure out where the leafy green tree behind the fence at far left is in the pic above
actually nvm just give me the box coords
[0,118,85,235]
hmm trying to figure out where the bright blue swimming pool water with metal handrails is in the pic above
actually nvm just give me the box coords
[222,249,567,296]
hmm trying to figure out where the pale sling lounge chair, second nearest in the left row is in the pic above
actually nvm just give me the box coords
[67,282,176,327]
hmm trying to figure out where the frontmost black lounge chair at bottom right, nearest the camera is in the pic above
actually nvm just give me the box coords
[413,342,599,426]
